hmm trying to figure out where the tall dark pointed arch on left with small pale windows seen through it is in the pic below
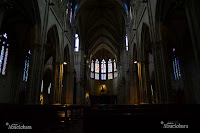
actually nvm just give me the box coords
[41,26,61,104]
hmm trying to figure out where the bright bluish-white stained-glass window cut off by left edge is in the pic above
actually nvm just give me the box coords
[0,33,9,75]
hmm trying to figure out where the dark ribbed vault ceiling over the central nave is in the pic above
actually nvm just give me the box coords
[76,0,125,54]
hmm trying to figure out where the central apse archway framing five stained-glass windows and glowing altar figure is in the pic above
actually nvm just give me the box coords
[86,43,118,104]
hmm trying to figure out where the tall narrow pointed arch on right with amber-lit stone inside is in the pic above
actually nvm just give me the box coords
[139,24,154,103]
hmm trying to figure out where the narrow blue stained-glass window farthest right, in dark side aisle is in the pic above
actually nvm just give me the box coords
[172,48,181,80]
